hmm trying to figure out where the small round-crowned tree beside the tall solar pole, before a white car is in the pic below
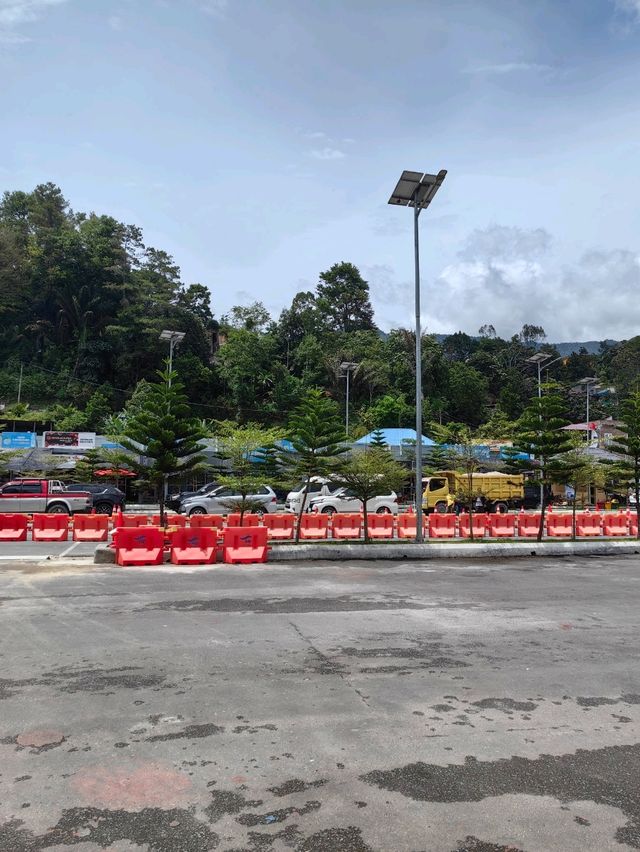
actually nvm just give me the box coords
[332,449,407,542]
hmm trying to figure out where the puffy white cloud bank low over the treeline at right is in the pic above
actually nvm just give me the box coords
[363,226,640,342]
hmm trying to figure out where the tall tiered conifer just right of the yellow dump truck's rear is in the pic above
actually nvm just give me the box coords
[508,385,572,541]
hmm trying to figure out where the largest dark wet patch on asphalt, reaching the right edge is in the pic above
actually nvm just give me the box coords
[361,743,640,849]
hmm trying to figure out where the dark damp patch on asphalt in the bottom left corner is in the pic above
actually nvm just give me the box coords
[0,808,219,852]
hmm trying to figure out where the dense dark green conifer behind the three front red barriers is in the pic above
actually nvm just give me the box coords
[118,361,205,526]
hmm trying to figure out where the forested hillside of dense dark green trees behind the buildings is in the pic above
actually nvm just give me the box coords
[0,184,640,437]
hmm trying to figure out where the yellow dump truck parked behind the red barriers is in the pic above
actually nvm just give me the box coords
[422,470,524,512]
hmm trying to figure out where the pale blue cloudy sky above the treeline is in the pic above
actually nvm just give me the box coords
[0,0,640,341]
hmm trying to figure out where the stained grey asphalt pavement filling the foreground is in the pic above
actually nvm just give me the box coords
[0,557,640,852]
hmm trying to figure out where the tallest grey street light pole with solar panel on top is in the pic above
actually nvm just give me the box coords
[389,169,447,542]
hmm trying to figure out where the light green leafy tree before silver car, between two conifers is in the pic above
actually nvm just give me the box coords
[214,420,282,524]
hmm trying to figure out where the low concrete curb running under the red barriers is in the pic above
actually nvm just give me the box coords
[93,539,640,565]
